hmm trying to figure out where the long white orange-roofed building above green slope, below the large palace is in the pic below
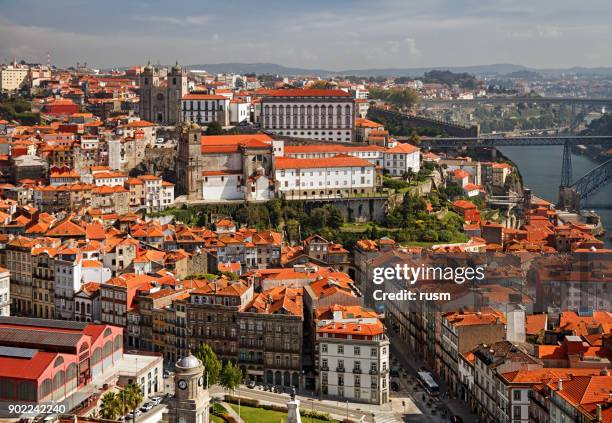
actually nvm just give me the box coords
[274,155,376,198]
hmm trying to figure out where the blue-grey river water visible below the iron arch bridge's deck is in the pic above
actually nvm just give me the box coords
[499,146,612,247]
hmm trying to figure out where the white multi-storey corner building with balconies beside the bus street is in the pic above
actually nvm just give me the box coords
[316,306,389,404]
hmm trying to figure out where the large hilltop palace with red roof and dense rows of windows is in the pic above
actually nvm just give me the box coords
[261,89,355,142]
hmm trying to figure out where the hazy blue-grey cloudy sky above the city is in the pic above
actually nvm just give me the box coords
[0,0,612,71]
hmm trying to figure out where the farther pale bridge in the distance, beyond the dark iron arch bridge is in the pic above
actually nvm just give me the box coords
[418,97,612,106]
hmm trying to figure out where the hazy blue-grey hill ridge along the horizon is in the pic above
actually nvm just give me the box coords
[187,62,612,78]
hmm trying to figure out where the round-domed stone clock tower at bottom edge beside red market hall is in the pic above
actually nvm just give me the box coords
[163,352,210,423]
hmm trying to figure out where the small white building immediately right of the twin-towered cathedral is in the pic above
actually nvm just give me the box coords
[181,93,230,126]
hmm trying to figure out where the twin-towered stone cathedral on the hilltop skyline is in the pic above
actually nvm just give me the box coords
[138,62,189,125]
